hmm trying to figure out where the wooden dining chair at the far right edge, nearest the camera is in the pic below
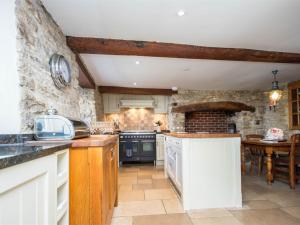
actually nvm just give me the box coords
[273,134,300,189]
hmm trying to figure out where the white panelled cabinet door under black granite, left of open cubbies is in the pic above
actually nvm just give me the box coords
[0,155,56,225]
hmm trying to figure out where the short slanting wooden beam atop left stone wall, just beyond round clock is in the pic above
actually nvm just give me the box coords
[75,53,96,89]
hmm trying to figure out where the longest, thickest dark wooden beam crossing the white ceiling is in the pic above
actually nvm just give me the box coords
[67,36,300,63]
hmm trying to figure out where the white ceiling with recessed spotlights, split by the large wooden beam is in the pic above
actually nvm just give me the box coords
[42,0,300,89]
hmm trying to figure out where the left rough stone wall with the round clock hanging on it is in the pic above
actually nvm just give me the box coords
[16,0,95,133]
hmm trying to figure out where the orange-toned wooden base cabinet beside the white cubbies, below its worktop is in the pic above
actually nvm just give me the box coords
[70,144,118,225]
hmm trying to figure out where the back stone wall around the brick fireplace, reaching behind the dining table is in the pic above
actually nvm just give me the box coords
[169,88,300,138]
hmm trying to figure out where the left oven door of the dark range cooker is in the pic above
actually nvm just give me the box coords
[119,140,139,162]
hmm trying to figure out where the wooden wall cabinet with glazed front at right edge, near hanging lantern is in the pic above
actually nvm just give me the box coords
[288,81,300,129]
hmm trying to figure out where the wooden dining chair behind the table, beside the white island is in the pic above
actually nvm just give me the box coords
[246,134,264,176]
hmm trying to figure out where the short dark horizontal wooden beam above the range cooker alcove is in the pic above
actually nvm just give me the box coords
[98,86,177,95]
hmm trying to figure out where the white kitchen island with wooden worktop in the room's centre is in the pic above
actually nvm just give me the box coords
[165,133,242,210]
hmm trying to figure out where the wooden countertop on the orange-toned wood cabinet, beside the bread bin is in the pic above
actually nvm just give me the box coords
[72,135,118,148]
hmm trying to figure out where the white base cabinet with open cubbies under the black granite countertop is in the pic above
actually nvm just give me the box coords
[0,150,69,225]
